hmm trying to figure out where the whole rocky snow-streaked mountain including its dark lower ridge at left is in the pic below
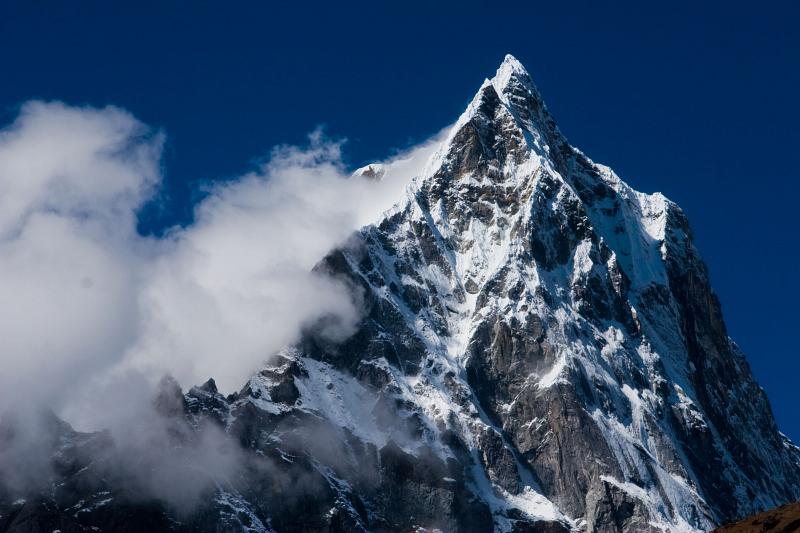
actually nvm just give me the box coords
[0,56,800,532]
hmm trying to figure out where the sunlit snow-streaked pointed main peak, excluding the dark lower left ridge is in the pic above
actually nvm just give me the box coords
[239,56,800,531]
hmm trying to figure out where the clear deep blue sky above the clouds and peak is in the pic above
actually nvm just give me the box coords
[0,0,800,442]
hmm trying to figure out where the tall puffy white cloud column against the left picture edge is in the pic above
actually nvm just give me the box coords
[0,102,161,412]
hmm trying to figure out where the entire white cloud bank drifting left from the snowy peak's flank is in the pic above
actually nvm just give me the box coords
[0,102,438,429]
